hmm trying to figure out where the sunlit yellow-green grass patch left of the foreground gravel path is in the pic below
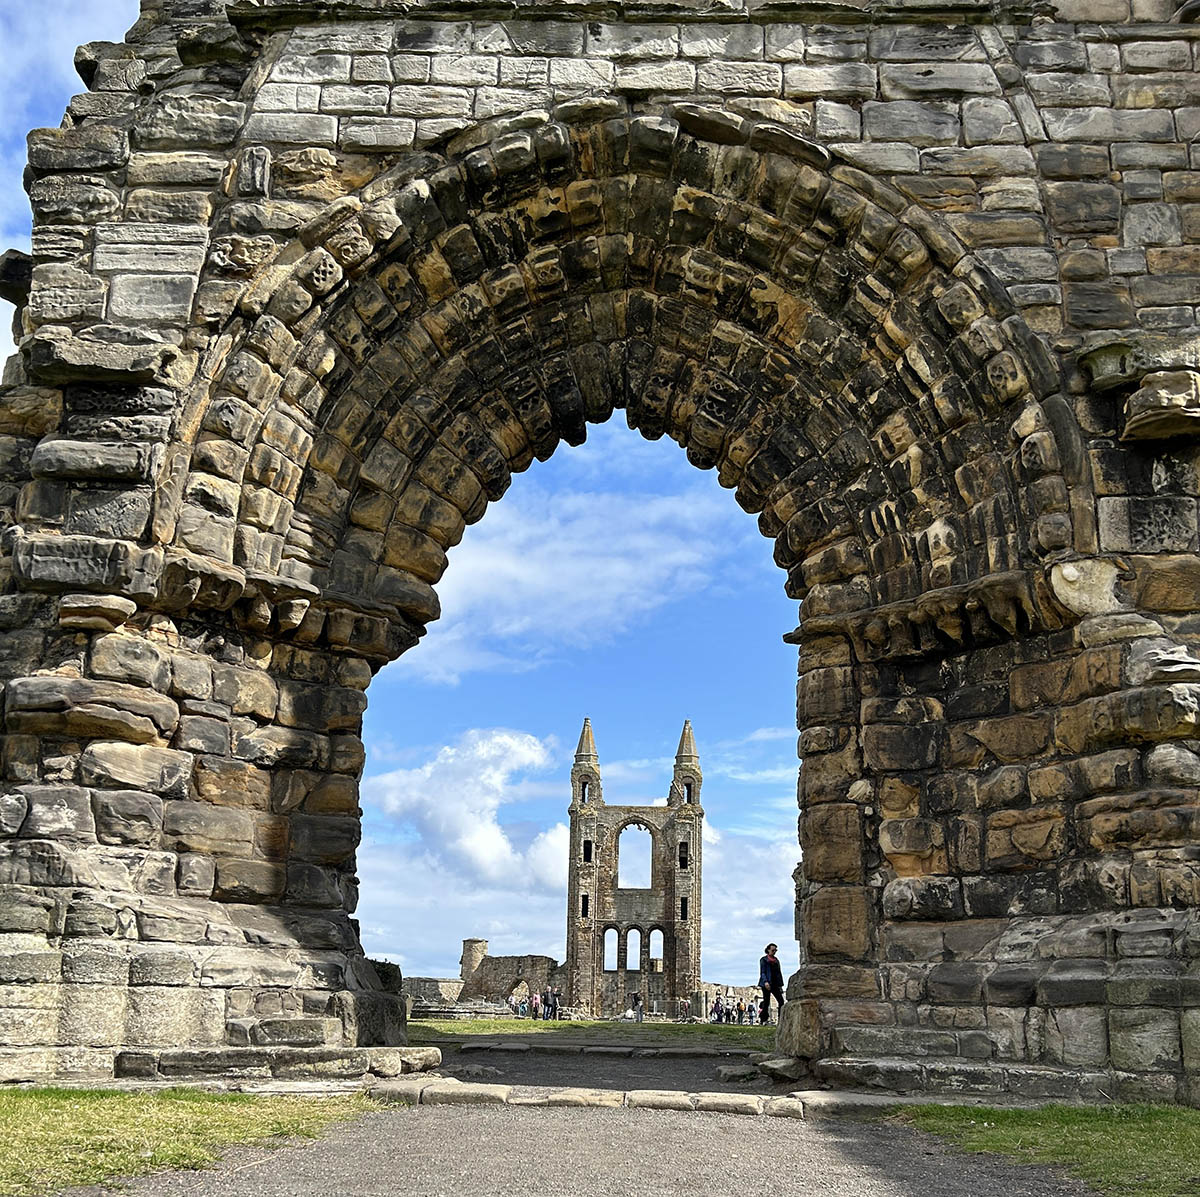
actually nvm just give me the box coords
[0,1089,372,1197]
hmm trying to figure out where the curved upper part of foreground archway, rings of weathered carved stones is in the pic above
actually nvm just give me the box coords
[163,102,1078,656]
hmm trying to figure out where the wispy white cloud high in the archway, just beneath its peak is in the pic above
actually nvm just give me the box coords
[392,421,761,684]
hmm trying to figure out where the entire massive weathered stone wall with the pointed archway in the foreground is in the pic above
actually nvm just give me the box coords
[0,0,1200,1097]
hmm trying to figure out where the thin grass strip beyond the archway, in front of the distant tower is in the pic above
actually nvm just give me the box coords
[408,1018,775,1052]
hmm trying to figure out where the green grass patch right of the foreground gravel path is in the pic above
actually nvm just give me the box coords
[895,1106,1200,1197]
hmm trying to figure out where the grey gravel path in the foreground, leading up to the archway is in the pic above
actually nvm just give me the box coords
[74,1106,1091,1197]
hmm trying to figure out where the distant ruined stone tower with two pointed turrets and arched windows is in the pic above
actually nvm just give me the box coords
[566,720,704,1017]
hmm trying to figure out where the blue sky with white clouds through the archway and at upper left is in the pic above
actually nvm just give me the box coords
[0,0,798,984]
